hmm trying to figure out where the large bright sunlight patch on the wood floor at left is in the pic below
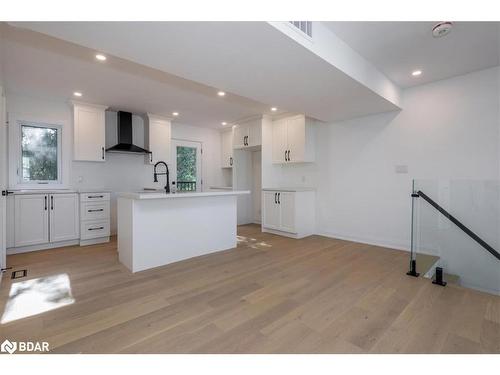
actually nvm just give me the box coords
[1,273,75,324]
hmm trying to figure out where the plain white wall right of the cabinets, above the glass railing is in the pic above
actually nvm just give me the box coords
[318,68,500,253]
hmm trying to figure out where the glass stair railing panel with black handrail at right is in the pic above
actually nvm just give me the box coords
[408,180,500,295]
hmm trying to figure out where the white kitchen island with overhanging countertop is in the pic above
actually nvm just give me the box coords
[117,191,250,272]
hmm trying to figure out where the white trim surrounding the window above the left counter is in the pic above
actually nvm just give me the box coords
[17,120,63,189]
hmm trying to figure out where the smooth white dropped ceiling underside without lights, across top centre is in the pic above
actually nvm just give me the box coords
[9,22,397,121]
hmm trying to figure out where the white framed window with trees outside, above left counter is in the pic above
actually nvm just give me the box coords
[17,121,62,187]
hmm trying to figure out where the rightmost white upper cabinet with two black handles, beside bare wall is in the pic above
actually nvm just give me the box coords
[273,115,315,164]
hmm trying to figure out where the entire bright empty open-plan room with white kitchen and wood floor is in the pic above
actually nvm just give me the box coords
[0,15,500,362]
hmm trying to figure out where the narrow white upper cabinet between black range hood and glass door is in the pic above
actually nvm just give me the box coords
[144,113,172,164]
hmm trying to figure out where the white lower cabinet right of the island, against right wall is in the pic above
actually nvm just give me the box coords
[262,189,315,238]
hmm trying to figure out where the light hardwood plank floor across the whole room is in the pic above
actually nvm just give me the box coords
[0,225,500,353]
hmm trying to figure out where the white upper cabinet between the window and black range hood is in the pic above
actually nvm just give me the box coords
[73,102,107,162]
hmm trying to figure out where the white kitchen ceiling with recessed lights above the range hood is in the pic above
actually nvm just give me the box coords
[0,25,270,128]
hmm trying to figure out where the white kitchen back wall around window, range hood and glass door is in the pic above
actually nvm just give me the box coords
[7,92,224,233]
